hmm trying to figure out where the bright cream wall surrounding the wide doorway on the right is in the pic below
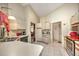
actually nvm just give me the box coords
[40,3,78,45]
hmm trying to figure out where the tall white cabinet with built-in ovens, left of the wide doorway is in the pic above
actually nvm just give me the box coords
[40,17,51,43]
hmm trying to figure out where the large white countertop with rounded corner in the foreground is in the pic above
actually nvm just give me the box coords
[0,41,43,56]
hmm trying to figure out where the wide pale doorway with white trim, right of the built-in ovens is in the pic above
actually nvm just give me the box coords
[52,22,62,43]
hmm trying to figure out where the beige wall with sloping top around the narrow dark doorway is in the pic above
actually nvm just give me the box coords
[25,5,39,42]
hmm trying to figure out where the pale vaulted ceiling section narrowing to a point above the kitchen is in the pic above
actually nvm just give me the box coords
[22,3,63,17]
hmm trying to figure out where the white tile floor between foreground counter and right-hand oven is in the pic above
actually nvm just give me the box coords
[35,42,68,56]
